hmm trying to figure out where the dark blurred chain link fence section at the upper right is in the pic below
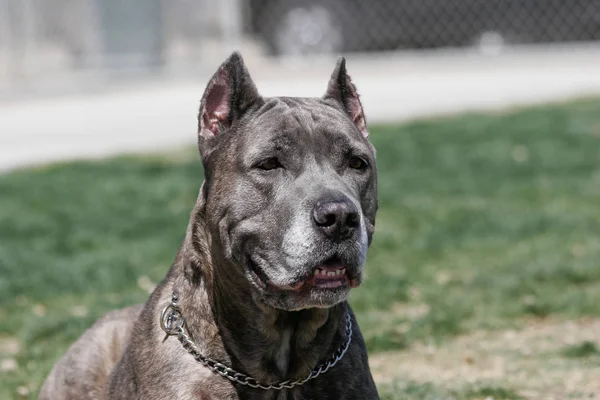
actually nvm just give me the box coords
[248,0,600,54]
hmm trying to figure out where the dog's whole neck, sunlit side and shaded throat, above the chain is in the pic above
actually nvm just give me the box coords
[174,212,347,383]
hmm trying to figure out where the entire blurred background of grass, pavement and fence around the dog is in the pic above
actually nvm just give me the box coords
[0,0,600,400]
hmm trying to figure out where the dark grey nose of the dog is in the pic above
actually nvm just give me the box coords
[313,200,360,240]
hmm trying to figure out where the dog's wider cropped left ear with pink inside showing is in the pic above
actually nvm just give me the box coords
[198,52,261,151]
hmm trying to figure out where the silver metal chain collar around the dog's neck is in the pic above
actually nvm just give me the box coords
[160,293,352,390]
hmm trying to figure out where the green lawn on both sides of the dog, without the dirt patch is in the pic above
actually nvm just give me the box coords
[0,100,600,399]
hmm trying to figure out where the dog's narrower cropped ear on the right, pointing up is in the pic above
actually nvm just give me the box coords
[323,57,369,137]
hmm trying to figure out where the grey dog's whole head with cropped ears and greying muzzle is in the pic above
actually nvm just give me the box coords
[199,54,377,310]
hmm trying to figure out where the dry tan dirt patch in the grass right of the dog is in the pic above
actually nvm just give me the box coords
[370,318,600,400]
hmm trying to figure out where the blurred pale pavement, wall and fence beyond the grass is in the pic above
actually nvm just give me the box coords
[0,0,600,168]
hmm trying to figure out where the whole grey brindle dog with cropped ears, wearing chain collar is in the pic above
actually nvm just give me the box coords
[40,52,379,400]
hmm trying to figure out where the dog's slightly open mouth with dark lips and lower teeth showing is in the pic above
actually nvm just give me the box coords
[248,257,360,293]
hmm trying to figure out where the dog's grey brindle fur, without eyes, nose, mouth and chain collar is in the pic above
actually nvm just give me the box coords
[40,53,378,400]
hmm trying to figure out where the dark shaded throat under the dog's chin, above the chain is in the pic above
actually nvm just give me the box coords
[213,256,346,382]
